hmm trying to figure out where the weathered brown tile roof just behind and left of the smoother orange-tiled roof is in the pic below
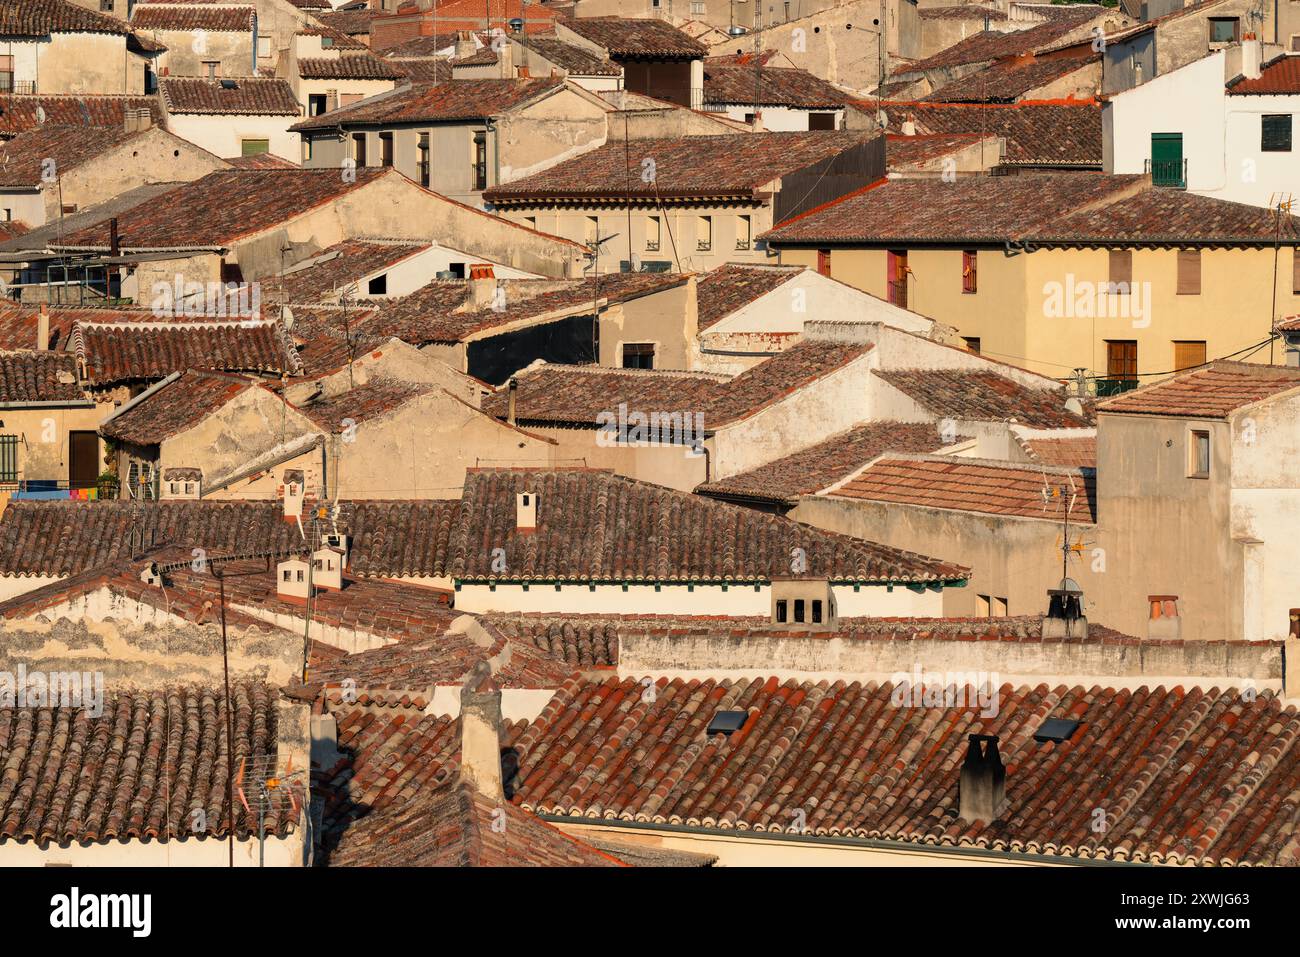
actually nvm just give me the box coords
[696,423,965,506]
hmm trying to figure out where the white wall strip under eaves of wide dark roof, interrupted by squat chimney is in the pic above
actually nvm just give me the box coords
[456,584,943,618]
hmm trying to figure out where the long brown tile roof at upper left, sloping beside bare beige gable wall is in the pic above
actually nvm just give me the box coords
[55,168,394,250]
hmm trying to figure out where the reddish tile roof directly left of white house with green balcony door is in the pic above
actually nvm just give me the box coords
[872,103,1102,169]
